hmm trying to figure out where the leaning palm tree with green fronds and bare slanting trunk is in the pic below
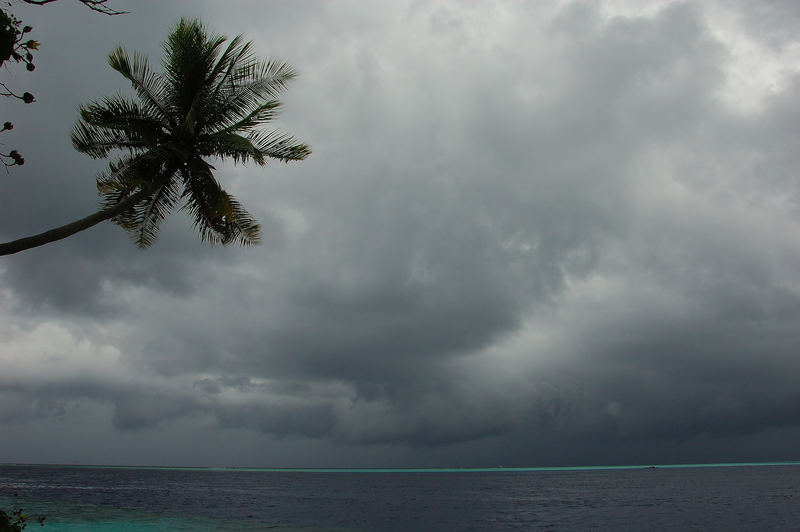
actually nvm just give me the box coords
[0,20,311,255]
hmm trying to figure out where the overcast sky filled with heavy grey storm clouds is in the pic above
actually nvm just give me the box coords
[0,0,800,467]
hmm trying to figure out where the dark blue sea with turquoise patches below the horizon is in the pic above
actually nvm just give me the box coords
[0,462,800,532]
